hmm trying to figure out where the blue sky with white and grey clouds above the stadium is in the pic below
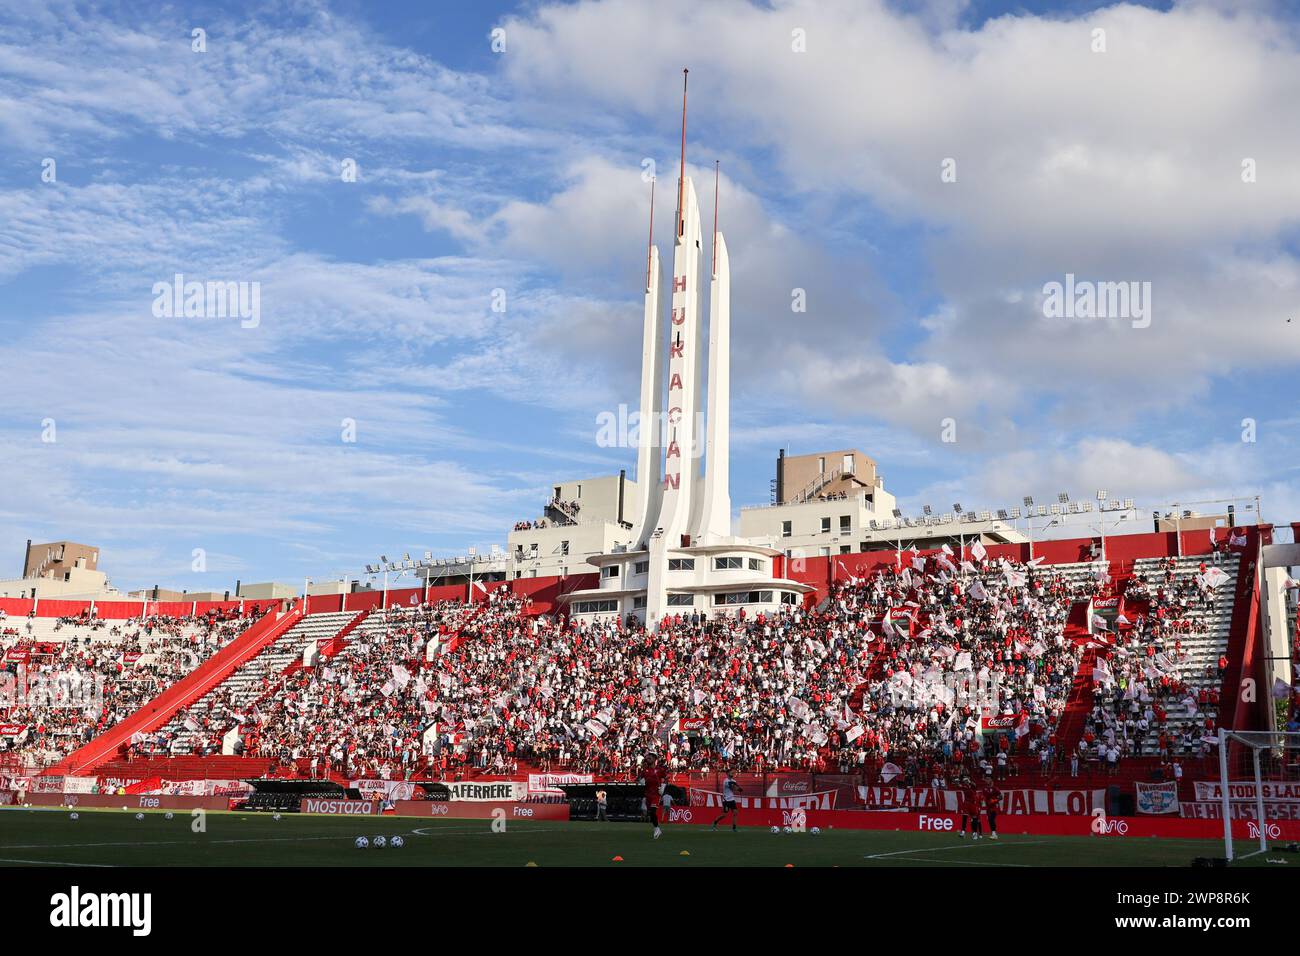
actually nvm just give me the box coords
[0,0,1300,589]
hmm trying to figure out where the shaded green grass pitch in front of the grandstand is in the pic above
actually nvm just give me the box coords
[0,808,1284,870]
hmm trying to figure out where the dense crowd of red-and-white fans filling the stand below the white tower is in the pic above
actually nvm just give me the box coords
[91,551,1192,782]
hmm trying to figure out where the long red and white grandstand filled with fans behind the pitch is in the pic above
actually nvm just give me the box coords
[0,525,1300,837]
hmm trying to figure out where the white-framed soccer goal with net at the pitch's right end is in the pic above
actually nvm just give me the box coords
[1218,730,1300,862]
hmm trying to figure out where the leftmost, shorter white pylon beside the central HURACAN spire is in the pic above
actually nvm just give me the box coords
[632,181,664,550]
